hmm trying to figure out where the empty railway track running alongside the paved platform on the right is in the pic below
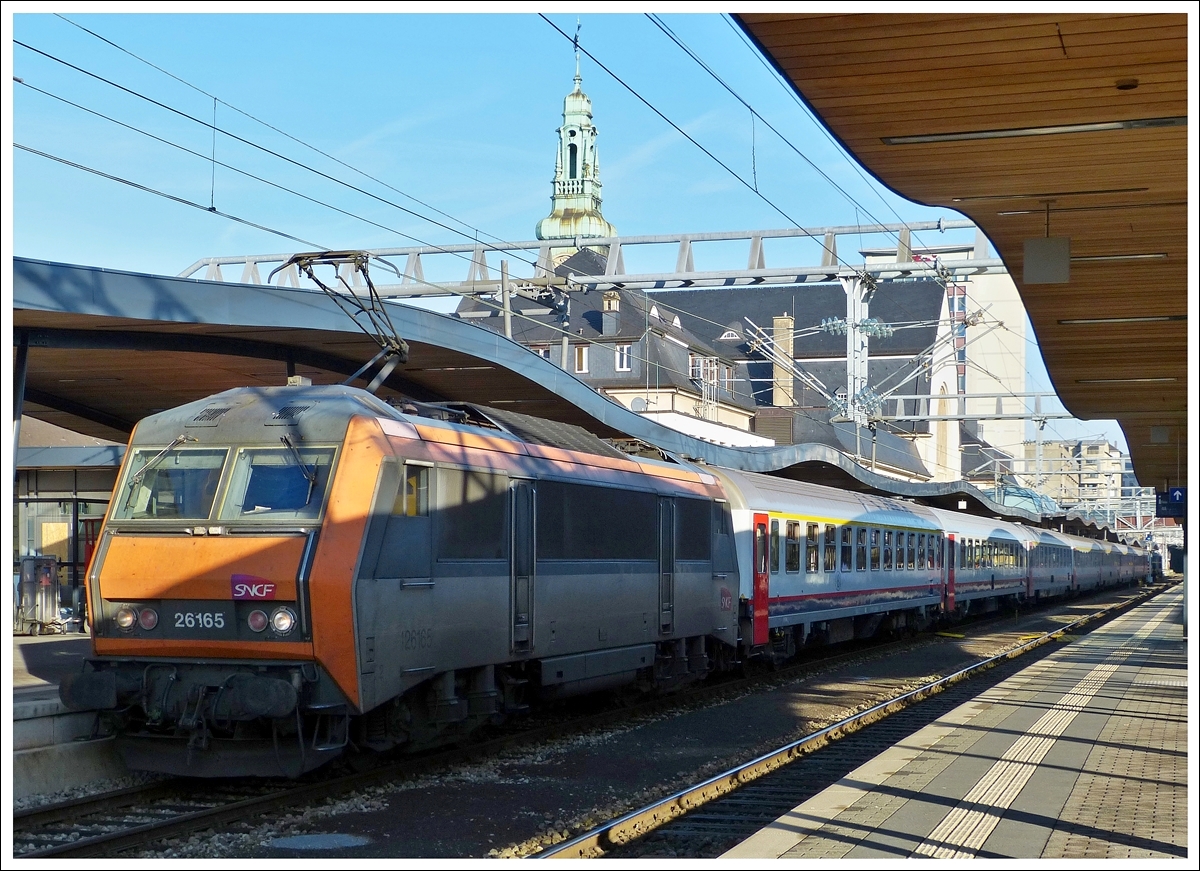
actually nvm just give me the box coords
[534,585,1165,859]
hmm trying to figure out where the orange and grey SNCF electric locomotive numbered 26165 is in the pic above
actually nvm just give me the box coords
[60,386,738,776]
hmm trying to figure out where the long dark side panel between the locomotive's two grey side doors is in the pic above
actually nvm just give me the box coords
[538,481,657,559]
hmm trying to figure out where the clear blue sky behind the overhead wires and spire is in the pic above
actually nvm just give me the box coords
[5,4,1123,444]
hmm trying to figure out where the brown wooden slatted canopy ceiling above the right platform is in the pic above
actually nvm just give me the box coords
[737,13,1188,487]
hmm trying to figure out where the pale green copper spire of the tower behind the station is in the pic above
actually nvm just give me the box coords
[536,50,617,239]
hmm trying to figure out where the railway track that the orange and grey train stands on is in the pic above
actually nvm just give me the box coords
[13,583,1161,858]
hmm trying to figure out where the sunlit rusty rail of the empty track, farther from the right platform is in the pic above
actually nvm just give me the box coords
[530,584,1170,859]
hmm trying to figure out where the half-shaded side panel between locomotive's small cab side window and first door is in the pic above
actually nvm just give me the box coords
[436,468,509,560]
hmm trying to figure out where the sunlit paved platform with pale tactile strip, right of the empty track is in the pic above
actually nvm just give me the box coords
[722,585,1194,860]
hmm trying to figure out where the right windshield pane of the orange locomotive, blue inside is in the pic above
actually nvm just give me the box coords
[221,444,334,521]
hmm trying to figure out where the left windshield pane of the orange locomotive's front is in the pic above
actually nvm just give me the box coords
[113,447,228,519]
